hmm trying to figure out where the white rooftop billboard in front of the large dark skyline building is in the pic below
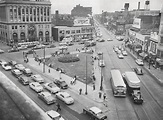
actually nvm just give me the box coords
[74,18,91,26]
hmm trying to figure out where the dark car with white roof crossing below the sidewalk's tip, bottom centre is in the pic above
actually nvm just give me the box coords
[83,107,107,120]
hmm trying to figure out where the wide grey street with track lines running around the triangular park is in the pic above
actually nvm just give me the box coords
[0,22,163,120]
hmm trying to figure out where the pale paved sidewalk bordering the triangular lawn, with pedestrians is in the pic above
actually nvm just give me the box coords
[27,52,108,111]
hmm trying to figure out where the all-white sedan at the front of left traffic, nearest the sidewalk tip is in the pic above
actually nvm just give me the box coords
[56,92,74,105]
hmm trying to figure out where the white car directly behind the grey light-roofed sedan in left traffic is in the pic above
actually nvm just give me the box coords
[29,82,43,93]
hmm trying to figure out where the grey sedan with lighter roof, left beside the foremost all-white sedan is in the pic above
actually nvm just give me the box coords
[38,92,56,105]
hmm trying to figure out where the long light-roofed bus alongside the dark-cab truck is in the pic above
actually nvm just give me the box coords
[110,69,126,97]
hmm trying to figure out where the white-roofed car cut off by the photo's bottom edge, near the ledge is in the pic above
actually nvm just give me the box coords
[46,110,64,120]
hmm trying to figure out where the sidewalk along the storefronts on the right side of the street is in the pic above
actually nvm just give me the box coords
[126,47,163,85]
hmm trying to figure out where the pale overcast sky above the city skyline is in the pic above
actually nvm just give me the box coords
[50,0,163,14]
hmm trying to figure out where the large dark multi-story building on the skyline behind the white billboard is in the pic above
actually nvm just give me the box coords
[71,4,92,17]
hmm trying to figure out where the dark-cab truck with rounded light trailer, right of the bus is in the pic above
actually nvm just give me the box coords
[122,72,143,104]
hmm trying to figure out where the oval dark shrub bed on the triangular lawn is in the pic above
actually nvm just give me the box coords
[58,55,80,63]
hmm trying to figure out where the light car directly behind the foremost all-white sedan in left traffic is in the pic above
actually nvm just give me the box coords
[44,83,61,93]
